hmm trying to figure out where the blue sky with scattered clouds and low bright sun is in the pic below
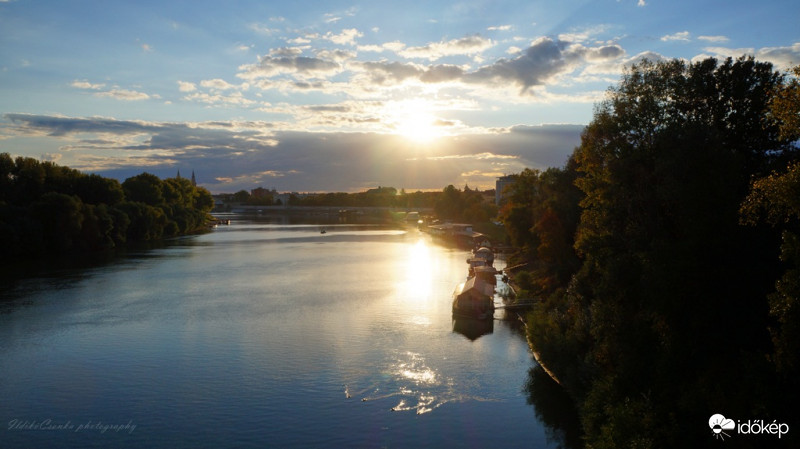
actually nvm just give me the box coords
[0,0,800,193]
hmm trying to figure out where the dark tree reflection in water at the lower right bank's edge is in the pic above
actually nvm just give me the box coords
[524,365,583,449]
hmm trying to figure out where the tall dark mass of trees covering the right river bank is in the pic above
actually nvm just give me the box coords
[500,58,800,448]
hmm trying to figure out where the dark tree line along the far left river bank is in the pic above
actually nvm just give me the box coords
[0,153,214,262]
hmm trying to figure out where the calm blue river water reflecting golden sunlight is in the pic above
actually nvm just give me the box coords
[0,217,576,448]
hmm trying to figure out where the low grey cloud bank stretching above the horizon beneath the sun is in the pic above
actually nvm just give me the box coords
[5,114,583,192]
